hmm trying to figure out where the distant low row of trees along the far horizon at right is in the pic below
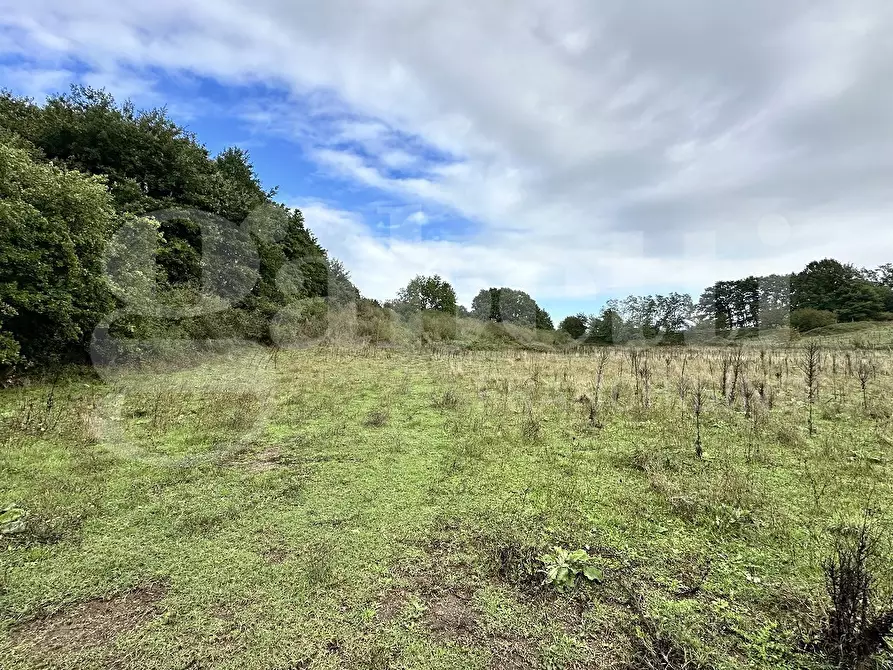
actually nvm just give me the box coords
[385,259,893,344]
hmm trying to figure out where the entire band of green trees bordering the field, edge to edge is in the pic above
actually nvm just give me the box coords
[0,87,893,376]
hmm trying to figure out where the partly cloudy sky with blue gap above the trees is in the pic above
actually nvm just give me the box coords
[0,0,893,319]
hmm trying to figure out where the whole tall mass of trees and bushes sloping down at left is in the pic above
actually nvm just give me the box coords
[0,87,359,367]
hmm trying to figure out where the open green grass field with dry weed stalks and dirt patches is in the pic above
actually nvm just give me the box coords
[0,347,893,670]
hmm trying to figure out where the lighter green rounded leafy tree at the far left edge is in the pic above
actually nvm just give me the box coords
[0,138,114,362]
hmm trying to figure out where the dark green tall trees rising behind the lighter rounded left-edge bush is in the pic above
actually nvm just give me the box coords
[0,87,359,360]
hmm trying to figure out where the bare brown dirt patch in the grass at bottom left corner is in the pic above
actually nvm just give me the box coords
[11,584,168,656]
